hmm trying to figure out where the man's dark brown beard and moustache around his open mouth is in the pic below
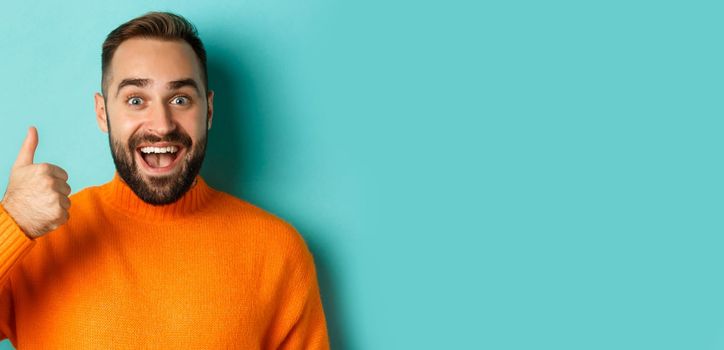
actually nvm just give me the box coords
[108,126,208,205]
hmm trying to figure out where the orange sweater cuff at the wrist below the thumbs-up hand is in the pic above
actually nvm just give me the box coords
[0,205,37,282]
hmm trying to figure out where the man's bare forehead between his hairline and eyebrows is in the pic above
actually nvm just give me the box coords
[109,38,201,91]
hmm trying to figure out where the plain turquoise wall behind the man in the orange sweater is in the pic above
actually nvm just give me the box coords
[0,0,724,350]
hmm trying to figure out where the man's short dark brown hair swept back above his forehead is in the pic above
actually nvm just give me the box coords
[101,12,209,96]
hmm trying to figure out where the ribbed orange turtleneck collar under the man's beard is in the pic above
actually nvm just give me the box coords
[100,172,213,222]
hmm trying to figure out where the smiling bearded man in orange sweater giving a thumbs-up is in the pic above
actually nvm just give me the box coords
[0,12,329,349]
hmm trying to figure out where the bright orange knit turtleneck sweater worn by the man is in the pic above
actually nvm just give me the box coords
[0,173,329,349]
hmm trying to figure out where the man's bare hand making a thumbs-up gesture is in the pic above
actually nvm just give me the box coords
[0,127,70,238]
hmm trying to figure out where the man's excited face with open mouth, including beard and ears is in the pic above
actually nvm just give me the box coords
[95,39,213,205]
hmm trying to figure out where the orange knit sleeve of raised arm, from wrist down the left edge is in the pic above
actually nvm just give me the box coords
[0,205,37,340]
